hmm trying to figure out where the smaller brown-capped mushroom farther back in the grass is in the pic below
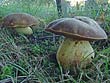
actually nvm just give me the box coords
[2,13,38,35]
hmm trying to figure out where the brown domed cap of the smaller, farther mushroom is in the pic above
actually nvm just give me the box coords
[3,13,38,28]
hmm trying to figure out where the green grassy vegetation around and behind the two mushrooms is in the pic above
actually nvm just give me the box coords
[0,0,110,83]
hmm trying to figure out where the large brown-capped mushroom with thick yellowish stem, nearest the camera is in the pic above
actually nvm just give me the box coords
[45,16,107,69]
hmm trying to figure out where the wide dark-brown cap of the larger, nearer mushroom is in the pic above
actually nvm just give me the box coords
[45,16,107,40]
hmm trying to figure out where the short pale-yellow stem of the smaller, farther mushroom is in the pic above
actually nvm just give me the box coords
[15,27,33,35]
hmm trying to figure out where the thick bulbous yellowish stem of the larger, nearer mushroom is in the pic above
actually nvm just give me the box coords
[57,38,94,69]
